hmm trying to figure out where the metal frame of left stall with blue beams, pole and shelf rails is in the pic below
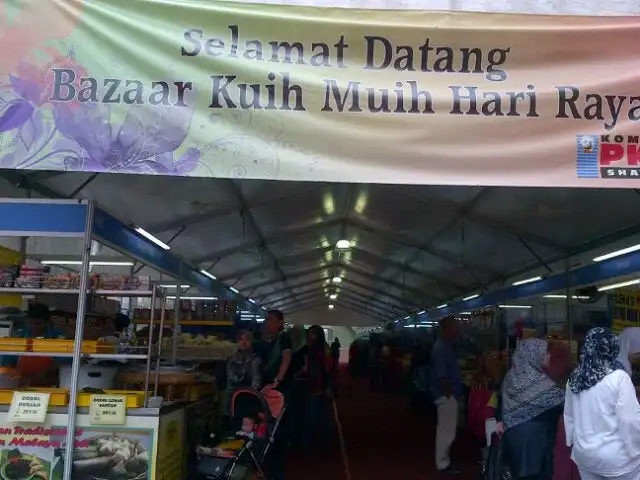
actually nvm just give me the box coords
[0,198,261,480]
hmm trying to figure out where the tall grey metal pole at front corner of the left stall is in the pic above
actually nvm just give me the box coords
[62,202,93,480]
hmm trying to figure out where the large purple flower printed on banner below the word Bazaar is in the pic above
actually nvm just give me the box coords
[54,102,200,175]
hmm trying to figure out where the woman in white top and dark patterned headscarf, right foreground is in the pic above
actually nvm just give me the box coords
[564,327,640,480]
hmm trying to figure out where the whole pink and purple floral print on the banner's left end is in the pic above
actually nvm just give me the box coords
[0,48,202,176]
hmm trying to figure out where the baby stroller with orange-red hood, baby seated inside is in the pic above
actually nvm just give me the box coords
[196,387,286,480]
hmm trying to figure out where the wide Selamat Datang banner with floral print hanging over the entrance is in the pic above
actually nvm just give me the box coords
[0,0,640,188]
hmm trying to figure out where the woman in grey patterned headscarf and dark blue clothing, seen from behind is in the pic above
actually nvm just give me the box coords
[497,339,564,480]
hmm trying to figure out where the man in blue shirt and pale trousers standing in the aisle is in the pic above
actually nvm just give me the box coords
[431,317,462,475]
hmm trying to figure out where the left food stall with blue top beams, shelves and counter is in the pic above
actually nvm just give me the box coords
[0,199,259,480]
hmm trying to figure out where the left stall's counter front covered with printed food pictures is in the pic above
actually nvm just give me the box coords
[0,404,188,480]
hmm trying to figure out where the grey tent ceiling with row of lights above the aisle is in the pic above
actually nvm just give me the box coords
[2,172,640,321]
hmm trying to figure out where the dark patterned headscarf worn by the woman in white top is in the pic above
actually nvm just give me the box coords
[569,327,624,393]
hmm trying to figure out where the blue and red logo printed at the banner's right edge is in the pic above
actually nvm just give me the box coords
[576,135,640,179]
